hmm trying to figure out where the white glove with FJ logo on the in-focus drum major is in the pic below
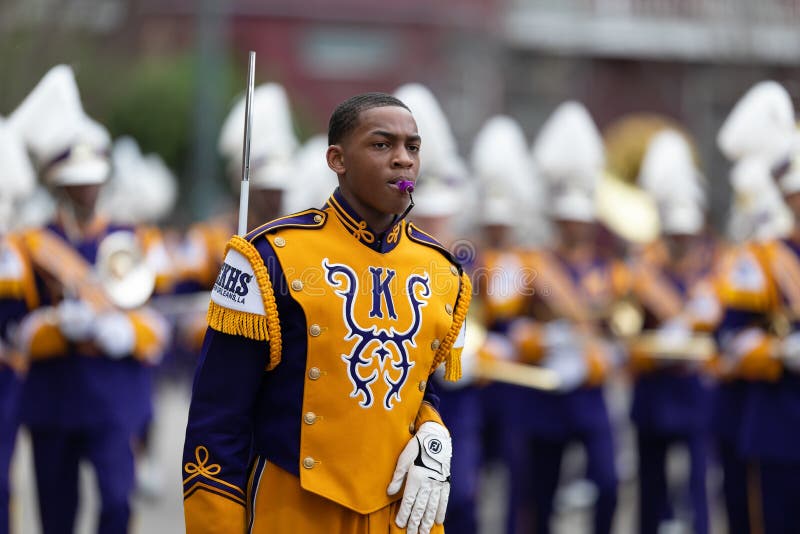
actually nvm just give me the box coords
[386,421,453,534]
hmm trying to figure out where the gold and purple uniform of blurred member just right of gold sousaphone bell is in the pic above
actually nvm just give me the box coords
[630,243,721,534]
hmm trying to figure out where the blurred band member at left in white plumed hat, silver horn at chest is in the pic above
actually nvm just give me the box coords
[9,65,167,534]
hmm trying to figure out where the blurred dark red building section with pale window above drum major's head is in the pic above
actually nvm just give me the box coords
[133,0,501,131]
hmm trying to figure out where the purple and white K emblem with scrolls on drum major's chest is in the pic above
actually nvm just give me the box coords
[322,258,431,410]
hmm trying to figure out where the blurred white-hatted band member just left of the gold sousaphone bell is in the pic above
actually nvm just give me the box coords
[500,102,626,533]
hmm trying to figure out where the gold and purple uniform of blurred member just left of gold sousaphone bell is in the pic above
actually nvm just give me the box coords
[508,250,629,533]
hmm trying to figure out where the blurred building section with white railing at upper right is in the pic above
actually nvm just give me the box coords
[502,0,800,227]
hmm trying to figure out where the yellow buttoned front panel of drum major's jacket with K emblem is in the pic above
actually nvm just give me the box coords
[265,218,460,516]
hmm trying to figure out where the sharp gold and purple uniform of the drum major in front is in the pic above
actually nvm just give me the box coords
[183,190,470,534]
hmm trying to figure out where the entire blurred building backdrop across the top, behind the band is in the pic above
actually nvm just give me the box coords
[0,0,800,226]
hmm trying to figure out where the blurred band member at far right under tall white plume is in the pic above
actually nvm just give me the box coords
[714,82,798,534]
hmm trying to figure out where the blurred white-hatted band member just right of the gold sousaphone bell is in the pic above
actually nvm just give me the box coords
[631,130,720,534]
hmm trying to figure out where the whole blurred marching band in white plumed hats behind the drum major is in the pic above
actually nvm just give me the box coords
[0,65,800,534]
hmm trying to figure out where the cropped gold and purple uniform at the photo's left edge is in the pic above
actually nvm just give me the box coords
[0,235,38,534]
